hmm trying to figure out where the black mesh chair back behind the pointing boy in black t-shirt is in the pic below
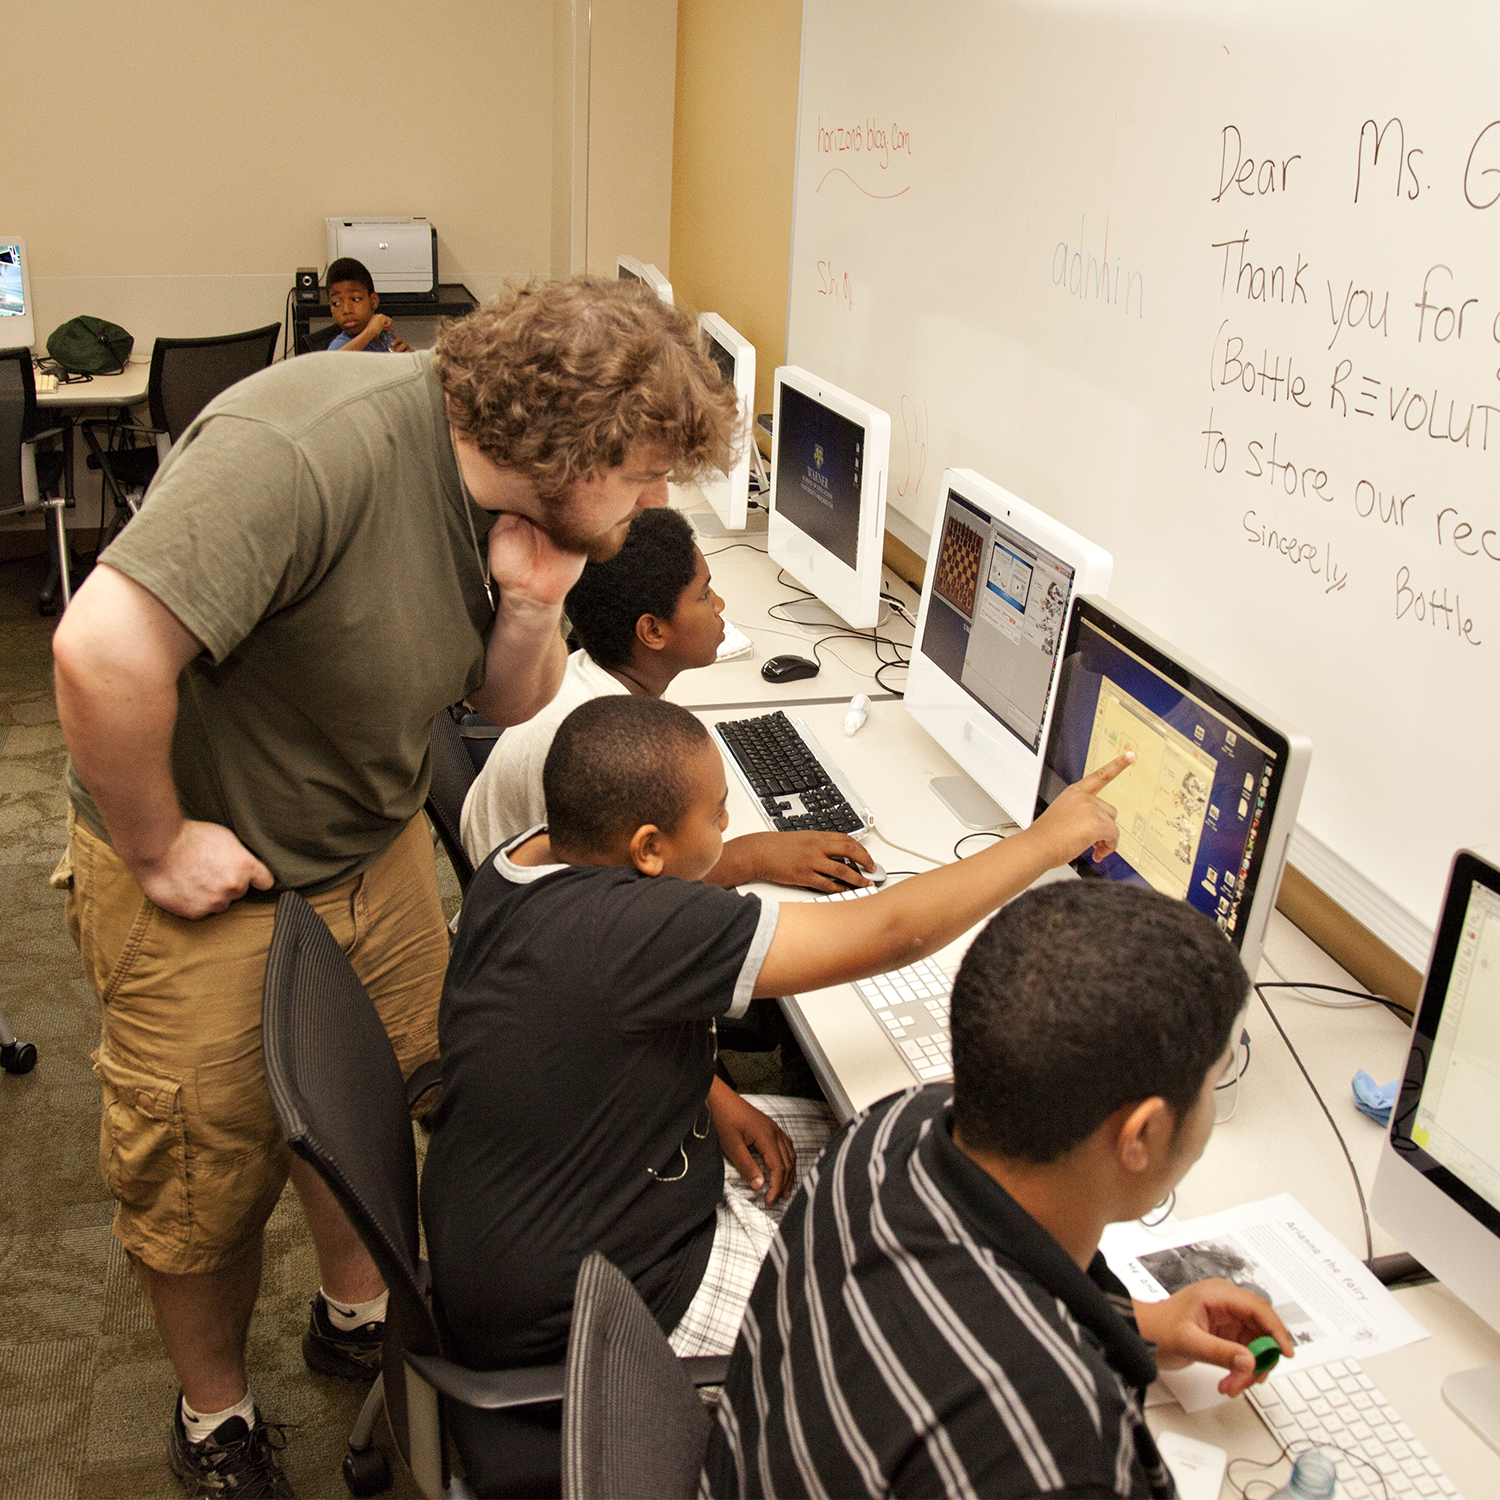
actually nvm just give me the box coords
[261,891,441,1355]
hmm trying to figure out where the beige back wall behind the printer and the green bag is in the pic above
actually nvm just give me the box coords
[0,0,552,344]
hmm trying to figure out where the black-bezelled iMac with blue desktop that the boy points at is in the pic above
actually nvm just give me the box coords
[1037,596,1313,978]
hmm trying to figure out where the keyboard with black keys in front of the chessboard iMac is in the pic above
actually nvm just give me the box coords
[714,713,875,834]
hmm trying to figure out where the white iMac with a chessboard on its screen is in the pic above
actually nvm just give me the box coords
[906,470,1115,828]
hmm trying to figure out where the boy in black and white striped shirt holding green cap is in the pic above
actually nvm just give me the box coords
[702,881,1292,1497]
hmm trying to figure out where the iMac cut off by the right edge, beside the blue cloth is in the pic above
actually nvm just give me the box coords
[1370,849,1500,1449]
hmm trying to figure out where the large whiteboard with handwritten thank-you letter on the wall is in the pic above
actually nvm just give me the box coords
[788,0,1500,966]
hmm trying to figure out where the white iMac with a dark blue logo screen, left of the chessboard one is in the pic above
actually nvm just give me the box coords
[767,365,891,630]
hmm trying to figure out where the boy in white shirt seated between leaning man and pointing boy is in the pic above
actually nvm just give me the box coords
[461,510,875,888]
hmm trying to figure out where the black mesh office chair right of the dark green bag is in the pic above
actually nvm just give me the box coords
[83,323,281,543]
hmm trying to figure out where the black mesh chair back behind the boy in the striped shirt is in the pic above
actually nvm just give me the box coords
[563,1251,708,1500]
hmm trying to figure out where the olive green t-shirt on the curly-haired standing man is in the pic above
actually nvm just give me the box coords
[68,354,494,890]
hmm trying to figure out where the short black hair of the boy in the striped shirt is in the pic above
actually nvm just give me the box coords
[953,881,1250,1163]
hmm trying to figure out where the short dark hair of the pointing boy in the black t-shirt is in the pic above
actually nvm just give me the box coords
[542,693,713,854]
